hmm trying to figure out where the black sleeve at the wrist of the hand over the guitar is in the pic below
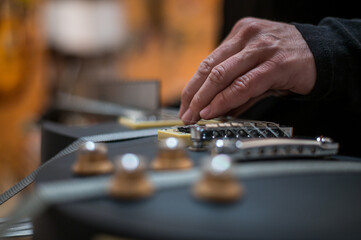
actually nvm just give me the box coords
[294,17,361,112]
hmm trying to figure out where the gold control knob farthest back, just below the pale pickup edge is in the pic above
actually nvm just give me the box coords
[151,137,193,170]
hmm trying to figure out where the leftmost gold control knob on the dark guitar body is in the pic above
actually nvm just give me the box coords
[72,141,114,175]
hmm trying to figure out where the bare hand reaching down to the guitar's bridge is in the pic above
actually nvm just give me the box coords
[179,18,316,124]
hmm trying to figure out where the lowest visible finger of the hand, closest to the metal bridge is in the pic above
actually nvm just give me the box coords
[200,63,278,119]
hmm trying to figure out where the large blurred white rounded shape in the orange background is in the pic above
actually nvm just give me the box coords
[43,0,126,55]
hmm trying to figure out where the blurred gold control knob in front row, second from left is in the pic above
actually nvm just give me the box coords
[109,153,154,199]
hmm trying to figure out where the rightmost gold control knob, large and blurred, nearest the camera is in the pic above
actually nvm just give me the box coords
[192,154,243,203]
